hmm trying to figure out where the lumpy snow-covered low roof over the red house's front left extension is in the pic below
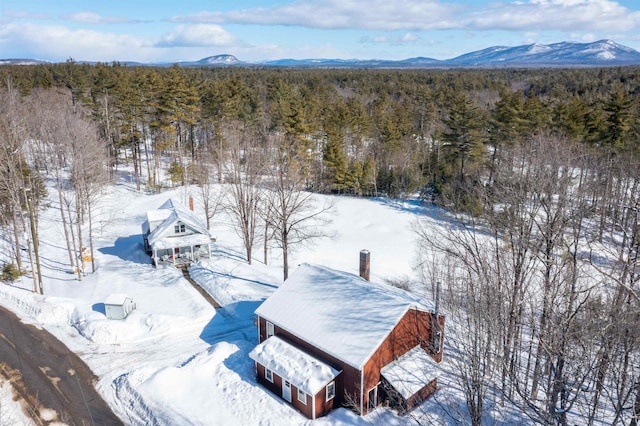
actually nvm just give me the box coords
[249,336,340,395]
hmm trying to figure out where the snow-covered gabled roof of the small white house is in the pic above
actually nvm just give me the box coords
[147,198,211,249]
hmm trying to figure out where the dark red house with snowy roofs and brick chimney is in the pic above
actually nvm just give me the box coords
[249,264,444,419]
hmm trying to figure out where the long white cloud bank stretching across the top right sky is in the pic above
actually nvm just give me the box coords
[171,0,640,32]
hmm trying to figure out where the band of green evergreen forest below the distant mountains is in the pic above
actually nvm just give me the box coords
[0,60,640,205]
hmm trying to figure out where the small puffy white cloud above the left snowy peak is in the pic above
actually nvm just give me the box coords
[157,24,240,47]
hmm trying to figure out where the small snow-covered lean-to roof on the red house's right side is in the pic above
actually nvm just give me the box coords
[380,346,440,400]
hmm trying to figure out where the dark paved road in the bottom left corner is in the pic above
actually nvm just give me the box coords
[0,306,122,426]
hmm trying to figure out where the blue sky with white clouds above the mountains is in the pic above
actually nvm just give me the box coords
[0,0,640,62]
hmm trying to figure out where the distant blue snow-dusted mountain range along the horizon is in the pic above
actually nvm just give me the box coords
[0,40,640,69]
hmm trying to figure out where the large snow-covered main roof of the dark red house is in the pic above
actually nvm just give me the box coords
[256,264,433,369]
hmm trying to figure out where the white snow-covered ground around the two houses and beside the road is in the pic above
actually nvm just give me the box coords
[0,178,462,425]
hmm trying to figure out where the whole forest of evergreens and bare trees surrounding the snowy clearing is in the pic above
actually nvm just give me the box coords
[0,60,640,424]
